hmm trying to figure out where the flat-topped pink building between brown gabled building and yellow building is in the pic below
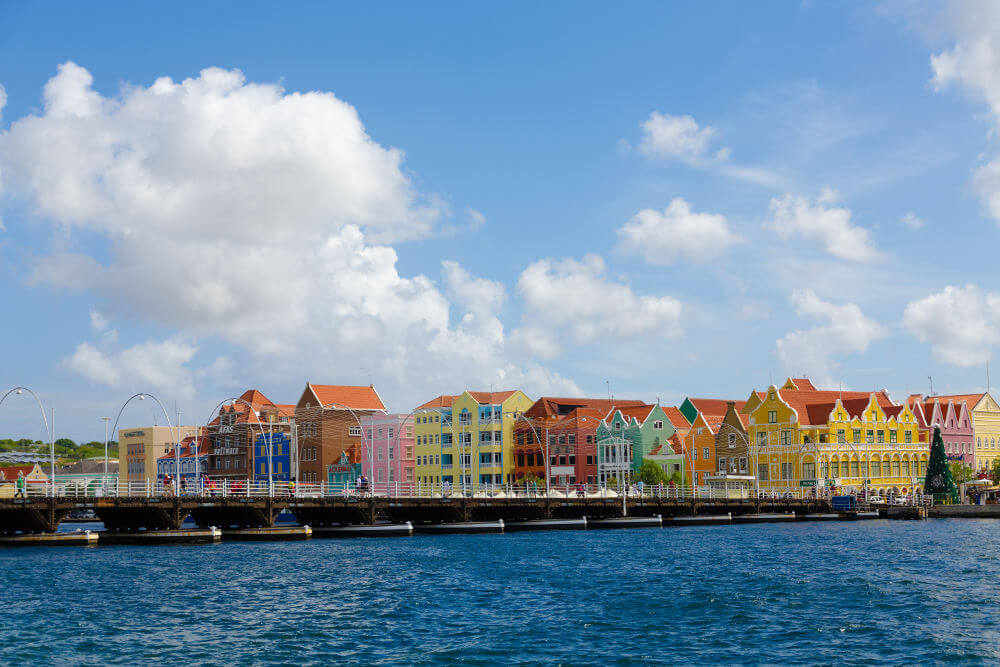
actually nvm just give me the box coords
[361,414,414,490]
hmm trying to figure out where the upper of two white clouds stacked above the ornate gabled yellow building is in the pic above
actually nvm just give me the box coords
[765,189,879,262]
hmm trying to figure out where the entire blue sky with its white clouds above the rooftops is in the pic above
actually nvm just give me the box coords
[0,0,1000,440]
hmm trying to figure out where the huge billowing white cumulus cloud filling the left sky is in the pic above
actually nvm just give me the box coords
[0,63,575,405]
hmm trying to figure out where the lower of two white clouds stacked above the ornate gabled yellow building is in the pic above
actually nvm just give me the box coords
[775,289,887,384]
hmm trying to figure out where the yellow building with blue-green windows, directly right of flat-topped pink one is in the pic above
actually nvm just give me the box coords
[413,390,533,491]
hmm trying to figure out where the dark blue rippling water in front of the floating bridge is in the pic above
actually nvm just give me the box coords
[0,520,1000,665]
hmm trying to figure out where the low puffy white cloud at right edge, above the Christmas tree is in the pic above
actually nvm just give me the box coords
[903,285,1000,366]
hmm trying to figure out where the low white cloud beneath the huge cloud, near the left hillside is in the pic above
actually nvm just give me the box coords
[64,338,197,398]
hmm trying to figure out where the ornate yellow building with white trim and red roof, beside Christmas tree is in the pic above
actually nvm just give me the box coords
[747,385,930,495]
